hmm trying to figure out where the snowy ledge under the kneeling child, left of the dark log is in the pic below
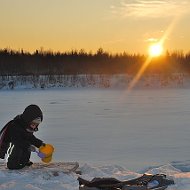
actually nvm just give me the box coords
[0,163,79,190]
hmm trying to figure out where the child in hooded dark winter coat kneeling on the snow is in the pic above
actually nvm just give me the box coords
[0,105,45,169]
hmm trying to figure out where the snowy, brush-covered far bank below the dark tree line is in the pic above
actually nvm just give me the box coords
[0,73,190,90]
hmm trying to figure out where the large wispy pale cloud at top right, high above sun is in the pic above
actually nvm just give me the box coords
[111,0,190,18]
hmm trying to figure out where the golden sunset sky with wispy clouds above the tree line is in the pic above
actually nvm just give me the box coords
[0,0,190,54]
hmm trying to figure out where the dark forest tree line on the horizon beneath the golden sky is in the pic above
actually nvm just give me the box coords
[0,48,190,76]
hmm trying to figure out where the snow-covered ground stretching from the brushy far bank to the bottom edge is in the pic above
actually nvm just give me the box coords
[0,88,190,190]
